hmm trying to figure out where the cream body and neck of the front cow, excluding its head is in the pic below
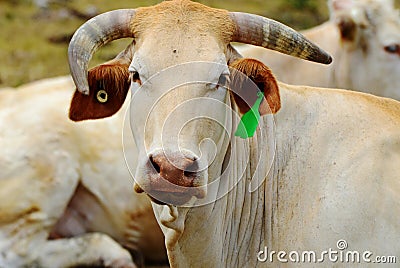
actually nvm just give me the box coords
[153,83,400,267]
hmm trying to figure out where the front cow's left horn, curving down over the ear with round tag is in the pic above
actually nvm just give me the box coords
[68,9,136,95]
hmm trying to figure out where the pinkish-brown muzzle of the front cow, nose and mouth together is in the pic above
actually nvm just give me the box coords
[135,153,205,206]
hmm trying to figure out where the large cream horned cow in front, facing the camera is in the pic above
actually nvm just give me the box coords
[68,0,400,267]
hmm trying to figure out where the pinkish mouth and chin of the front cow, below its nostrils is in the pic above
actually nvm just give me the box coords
[134,179,206,206]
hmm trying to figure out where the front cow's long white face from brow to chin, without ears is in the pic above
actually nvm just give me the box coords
[129,44,231,204]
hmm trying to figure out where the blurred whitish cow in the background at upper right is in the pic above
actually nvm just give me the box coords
[237,0,400,100]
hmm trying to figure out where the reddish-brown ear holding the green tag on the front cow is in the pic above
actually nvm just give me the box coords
[229,58,281,115]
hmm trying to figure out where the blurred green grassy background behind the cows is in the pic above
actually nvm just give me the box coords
[0,0,400,87]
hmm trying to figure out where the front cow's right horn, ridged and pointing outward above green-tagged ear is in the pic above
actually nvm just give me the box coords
[229,12,332,64]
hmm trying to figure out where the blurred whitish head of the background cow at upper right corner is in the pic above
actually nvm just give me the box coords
[330,0,400,96]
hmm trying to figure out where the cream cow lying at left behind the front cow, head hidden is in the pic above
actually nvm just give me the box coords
[0,76,167,268]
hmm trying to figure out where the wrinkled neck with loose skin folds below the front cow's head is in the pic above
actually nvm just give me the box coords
[155,106,276,267]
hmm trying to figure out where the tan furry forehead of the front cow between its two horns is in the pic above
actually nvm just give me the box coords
[127,1,234,76]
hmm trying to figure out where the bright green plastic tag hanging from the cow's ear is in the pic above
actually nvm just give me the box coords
[235,92,264,139]
